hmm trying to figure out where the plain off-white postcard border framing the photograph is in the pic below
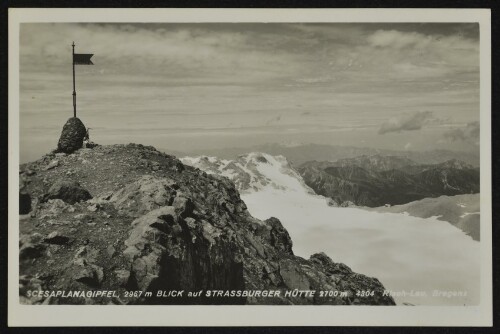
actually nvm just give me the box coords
[8,8,492,326]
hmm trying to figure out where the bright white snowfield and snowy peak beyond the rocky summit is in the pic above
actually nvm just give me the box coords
[182,153,480,305]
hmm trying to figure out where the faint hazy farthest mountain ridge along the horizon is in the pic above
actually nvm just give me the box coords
[171,144,479,167]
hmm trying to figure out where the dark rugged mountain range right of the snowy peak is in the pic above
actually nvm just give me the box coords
[298,155,479,207]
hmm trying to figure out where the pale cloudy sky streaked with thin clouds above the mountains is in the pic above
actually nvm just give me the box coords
[20,23,479,161]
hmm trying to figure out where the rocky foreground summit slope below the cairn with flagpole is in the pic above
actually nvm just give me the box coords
[19,144,394,305]
